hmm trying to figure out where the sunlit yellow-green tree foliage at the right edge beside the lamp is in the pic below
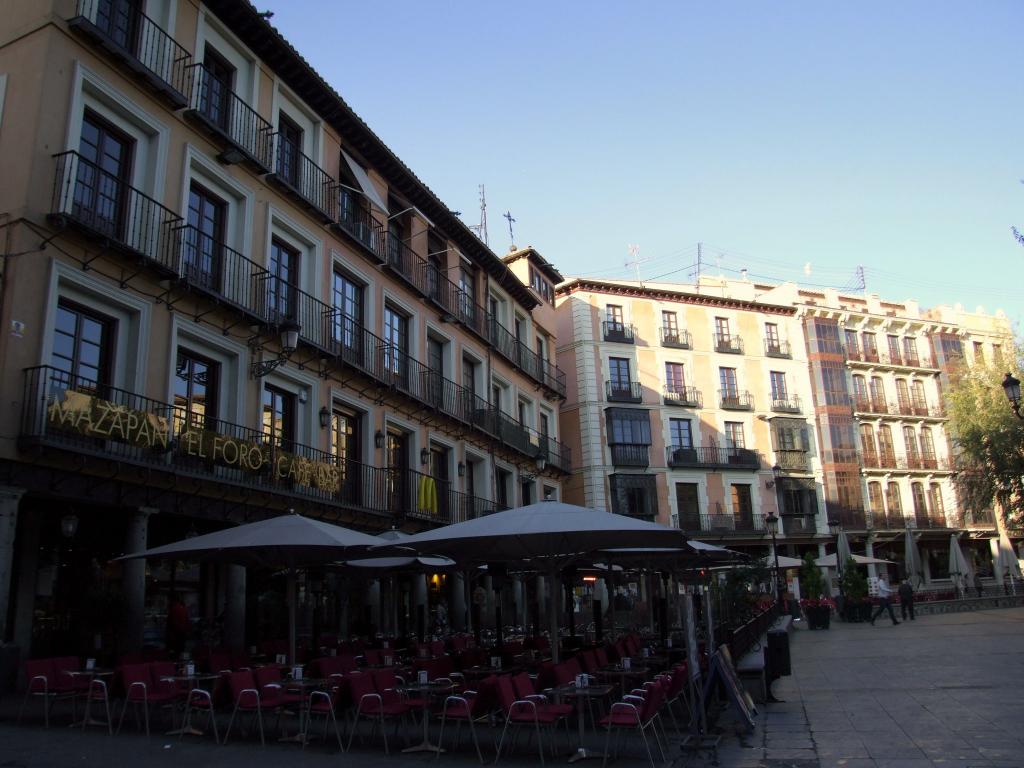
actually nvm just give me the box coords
[945,343,1024,528]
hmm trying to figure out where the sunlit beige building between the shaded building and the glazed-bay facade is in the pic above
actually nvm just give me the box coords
[556,278,827,555]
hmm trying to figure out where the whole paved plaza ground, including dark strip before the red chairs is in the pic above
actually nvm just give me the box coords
[0,608,1024,768]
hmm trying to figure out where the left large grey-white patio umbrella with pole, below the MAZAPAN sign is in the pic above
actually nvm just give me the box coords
[118,513,381,664]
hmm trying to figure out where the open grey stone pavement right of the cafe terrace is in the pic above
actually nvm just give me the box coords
[712,608,1024,768]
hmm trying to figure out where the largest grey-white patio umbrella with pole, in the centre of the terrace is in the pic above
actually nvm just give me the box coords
[389,501,686,662]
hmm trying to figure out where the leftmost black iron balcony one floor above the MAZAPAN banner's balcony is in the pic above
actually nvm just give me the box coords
[49,152,184,278]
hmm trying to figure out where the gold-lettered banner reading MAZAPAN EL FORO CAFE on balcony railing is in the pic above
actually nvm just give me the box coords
[47,390,342,493]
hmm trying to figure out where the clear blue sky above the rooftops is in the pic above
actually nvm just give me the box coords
[266,0,1024,331]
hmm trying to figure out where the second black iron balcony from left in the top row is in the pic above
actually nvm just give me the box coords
[183,65,273,174]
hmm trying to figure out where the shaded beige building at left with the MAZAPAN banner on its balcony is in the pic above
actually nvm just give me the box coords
[0,0,569,655]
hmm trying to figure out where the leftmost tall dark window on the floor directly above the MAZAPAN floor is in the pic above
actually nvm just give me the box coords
[72,112,134,240]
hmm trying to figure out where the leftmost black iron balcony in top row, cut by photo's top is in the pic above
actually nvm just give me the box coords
[68,0,191,110]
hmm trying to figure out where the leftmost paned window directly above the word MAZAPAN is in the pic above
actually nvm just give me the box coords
[50,299,114,392]
